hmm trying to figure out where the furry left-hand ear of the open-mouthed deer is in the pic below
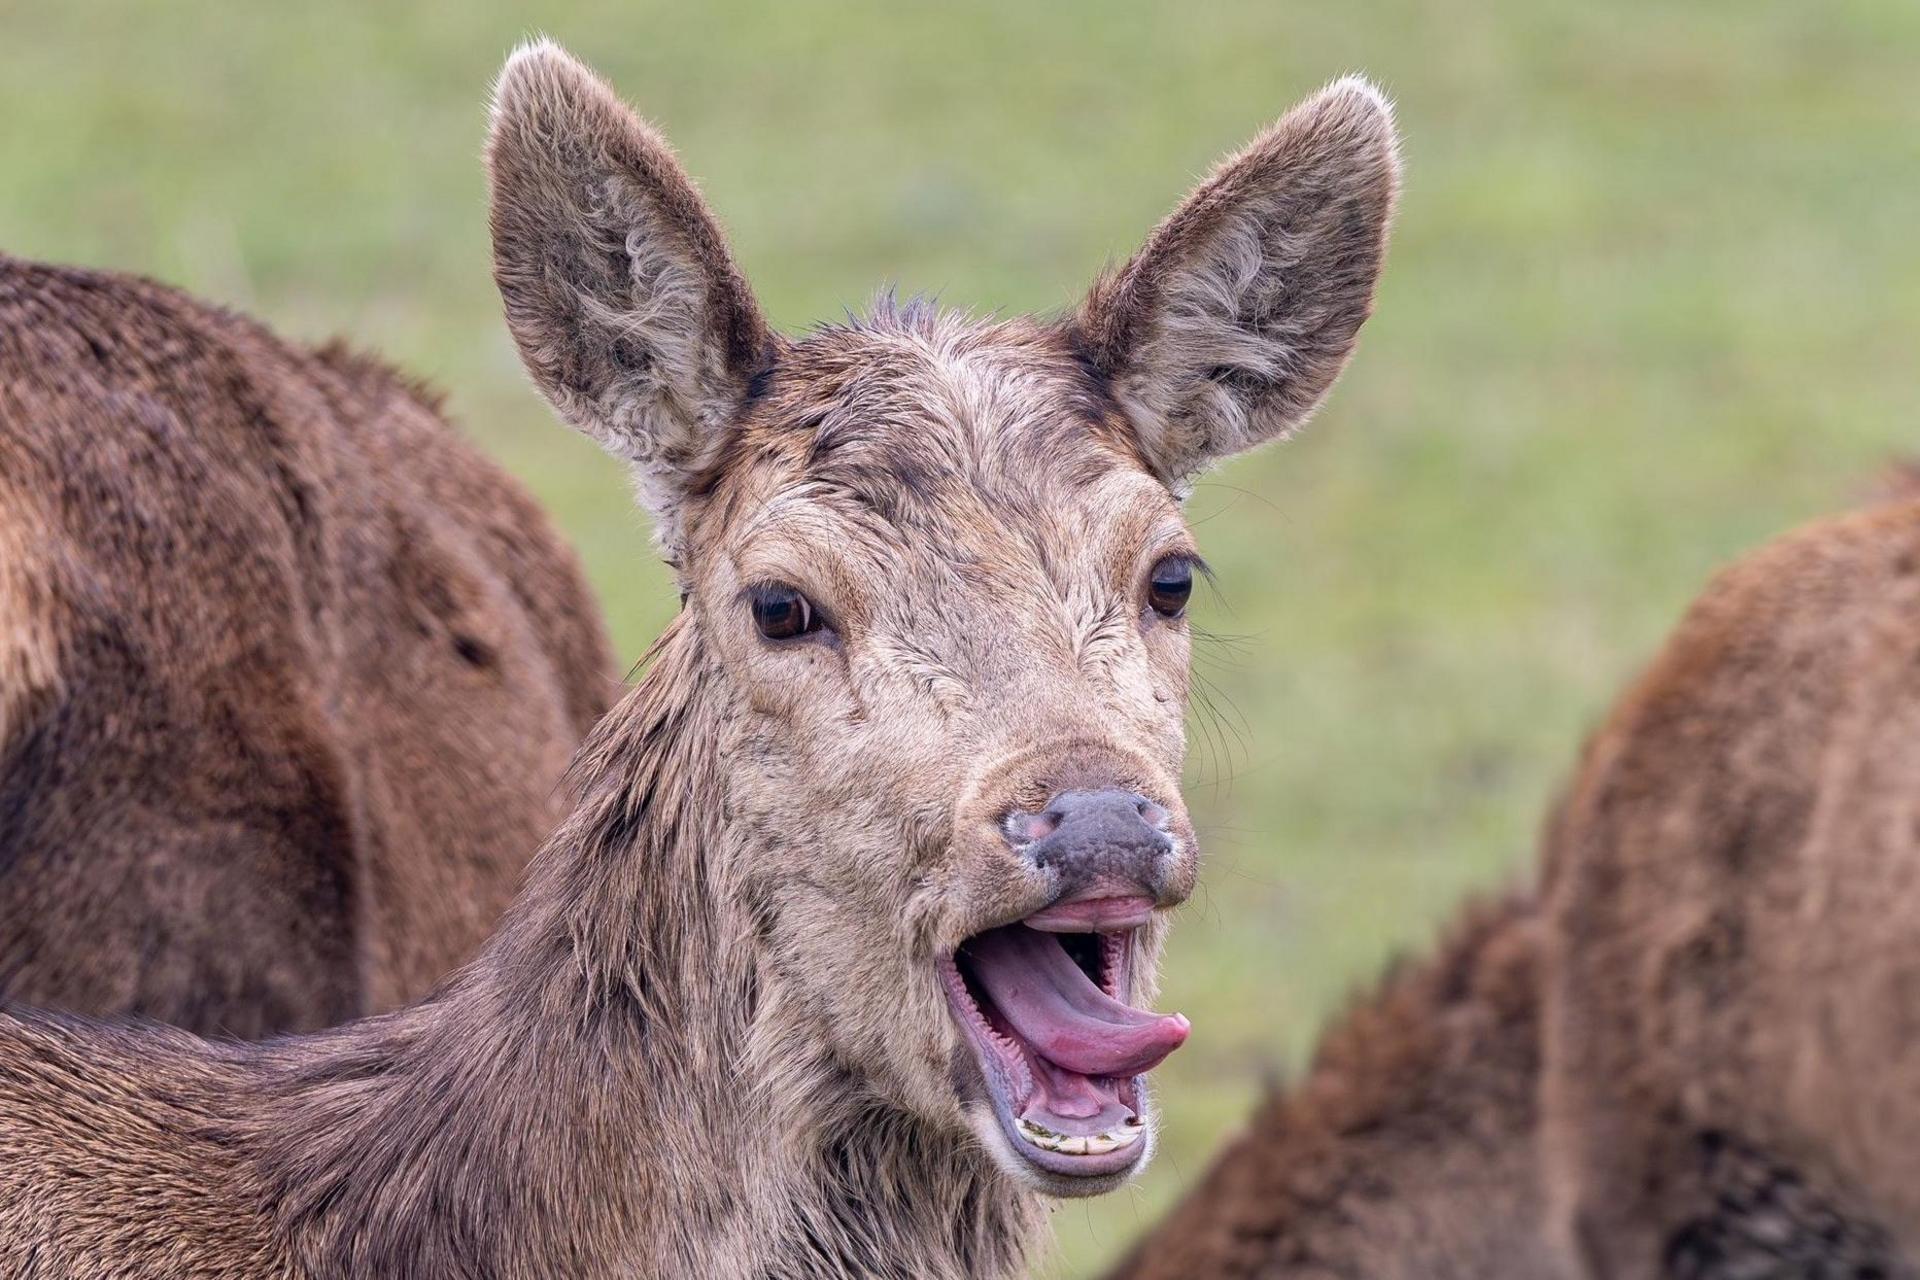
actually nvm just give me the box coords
[486,40,774,557]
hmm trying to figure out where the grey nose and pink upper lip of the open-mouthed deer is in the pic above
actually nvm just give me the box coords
[1002,787,1175,929]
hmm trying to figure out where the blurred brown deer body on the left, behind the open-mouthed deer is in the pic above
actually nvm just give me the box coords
[0,257,616,1036]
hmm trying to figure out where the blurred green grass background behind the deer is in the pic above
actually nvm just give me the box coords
[0,0,1920,1276]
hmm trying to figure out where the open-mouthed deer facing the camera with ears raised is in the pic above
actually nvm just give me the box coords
[0,42,1398,1280]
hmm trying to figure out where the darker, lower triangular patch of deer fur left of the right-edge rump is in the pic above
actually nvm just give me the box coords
[1112,896,1569,1280]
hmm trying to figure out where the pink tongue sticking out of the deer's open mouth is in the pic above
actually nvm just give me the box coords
[966,925,1187,1077]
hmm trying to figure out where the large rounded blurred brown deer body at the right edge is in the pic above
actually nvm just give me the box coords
[1544,501,1920,1278]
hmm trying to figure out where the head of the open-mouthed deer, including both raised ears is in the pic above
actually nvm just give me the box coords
[488,44,1396,1196]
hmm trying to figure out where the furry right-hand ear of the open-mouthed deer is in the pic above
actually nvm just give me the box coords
[1077,77,1400,487]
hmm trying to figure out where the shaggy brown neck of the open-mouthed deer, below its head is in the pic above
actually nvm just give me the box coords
[259,620,1037,1276]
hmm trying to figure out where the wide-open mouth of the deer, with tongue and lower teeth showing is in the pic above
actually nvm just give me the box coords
[941,910,1188,1190]
